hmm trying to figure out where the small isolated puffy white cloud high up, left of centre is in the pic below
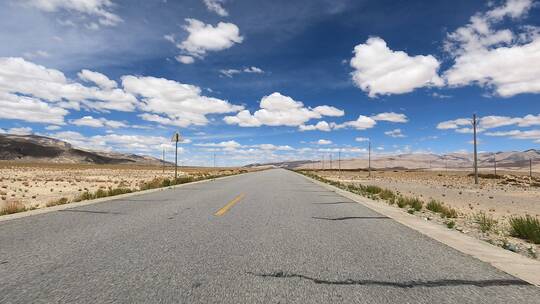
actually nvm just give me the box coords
[176,19,244,58]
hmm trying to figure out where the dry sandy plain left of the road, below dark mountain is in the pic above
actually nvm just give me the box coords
[0,162,248,209]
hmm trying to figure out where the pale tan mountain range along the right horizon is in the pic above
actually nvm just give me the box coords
[251,149,540,171]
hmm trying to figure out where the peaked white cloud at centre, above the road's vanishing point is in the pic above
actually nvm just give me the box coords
[223,92,343,127]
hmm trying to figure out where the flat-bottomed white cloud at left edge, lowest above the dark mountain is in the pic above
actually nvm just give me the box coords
[0,93,68,125]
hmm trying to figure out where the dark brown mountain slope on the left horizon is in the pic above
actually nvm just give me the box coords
[0,134,167,165]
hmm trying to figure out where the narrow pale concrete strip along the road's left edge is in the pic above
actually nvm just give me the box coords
[0,172,242,223]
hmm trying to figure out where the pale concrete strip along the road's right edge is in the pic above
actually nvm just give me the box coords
[298,173,540,286]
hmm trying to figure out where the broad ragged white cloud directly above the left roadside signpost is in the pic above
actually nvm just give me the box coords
[122,76,243,127]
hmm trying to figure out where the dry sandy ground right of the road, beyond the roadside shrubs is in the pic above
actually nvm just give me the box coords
[317,170,540,218]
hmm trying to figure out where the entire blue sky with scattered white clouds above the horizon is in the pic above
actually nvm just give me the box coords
[0,0,540,165]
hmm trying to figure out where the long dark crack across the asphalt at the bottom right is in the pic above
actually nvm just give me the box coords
[247,271,530,288]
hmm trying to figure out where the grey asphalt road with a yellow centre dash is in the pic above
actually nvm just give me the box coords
[0,170,540,304]
